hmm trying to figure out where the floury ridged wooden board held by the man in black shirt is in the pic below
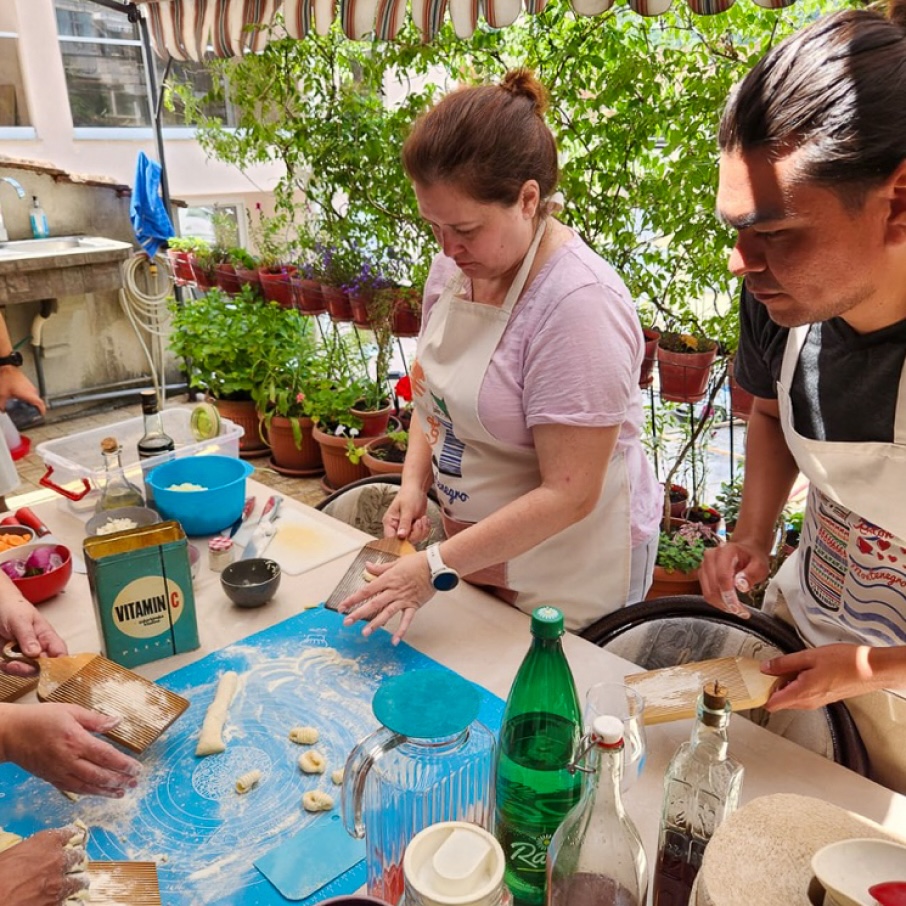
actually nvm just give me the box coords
[626,657,780,724]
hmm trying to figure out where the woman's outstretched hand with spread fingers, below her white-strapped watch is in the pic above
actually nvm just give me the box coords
[337,553,435,645]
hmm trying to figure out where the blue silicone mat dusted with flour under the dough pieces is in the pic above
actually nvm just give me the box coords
[0,608,503,906]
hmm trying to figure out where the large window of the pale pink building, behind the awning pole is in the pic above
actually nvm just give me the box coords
[55,0,228,127]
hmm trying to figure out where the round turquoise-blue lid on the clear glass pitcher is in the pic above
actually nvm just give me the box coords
[371,670,481,739]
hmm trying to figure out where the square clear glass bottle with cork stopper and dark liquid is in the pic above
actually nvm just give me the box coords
[654,682,743,906]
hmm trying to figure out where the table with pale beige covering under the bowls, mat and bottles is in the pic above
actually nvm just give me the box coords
[5,481,906,896]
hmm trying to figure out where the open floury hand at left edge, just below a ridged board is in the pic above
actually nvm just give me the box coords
[0,702,142,796]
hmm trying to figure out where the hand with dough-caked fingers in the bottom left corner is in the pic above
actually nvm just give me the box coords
[0,825,89,906]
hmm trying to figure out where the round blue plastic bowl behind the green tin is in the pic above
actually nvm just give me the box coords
[147,456,254,535]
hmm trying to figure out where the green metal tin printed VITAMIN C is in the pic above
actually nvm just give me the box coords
[83,521,199,667]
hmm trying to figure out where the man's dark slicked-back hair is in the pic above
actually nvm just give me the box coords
[718,0,906,206]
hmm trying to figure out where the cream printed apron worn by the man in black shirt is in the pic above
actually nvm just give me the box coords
[775,325,906,793]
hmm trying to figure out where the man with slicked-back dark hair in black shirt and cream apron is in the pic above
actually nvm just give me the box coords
[701,8,906,792]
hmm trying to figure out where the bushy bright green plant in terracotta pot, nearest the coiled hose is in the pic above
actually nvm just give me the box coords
[168,286,294,456]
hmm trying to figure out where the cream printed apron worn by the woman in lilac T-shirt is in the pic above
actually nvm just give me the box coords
[413,219,631,631]
